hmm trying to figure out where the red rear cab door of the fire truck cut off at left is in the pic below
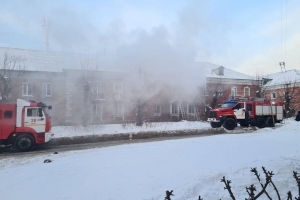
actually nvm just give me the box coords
[0,105,16,139]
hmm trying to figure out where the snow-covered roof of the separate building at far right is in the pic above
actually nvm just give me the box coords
[266,69,300,86]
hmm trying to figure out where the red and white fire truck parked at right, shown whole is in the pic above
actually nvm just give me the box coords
[207,98,283,130]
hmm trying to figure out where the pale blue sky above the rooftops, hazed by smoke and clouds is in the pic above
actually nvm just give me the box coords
[0,0,300,75]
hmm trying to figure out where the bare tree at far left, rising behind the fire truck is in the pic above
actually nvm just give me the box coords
[0,52,26,103]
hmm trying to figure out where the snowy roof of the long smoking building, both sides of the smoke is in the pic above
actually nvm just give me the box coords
[0,47,254,80]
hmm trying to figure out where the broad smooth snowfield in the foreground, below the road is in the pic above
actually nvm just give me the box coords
[0,120,300,200]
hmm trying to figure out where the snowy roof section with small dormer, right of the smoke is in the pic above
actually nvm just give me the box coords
[197,62,254,80]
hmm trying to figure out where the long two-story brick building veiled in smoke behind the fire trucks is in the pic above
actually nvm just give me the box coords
[0,49,268,125]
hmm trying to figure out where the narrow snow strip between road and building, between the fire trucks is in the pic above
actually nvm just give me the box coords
[52,120,210,138]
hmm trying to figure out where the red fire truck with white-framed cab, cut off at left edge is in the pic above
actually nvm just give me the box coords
[0,99,53,151]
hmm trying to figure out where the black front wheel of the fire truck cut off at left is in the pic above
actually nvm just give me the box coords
[14,133,35,152]
